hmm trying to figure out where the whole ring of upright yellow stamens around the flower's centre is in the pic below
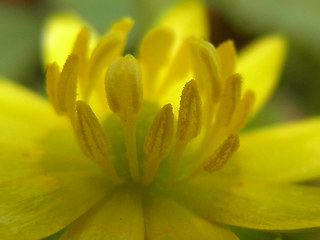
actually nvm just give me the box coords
[47,19,254,185]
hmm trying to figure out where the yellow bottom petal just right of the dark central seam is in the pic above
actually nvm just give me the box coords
[145,195,238,240]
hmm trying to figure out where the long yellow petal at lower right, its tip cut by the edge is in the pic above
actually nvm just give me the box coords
[170,174,320,231]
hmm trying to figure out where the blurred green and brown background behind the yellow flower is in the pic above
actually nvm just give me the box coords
[0,0,320,240]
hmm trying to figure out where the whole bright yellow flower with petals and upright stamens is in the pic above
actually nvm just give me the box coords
[0,2,320,240]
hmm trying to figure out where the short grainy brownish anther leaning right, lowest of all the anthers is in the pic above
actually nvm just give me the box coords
[204,134,240,172]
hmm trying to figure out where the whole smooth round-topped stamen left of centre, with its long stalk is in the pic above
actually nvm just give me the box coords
[105,55,142,181]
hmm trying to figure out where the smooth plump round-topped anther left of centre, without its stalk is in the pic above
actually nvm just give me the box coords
[105,55,142,121]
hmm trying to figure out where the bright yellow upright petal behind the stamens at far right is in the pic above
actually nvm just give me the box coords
[236,35,286,112]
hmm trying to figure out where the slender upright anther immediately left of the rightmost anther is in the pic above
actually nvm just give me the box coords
[214,74,242,130]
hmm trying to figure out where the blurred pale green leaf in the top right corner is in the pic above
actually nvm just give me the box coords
[209,0,320,54]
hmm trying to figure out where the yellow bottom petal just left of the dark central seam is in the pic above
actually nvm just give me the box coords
[59,191,145,240]
